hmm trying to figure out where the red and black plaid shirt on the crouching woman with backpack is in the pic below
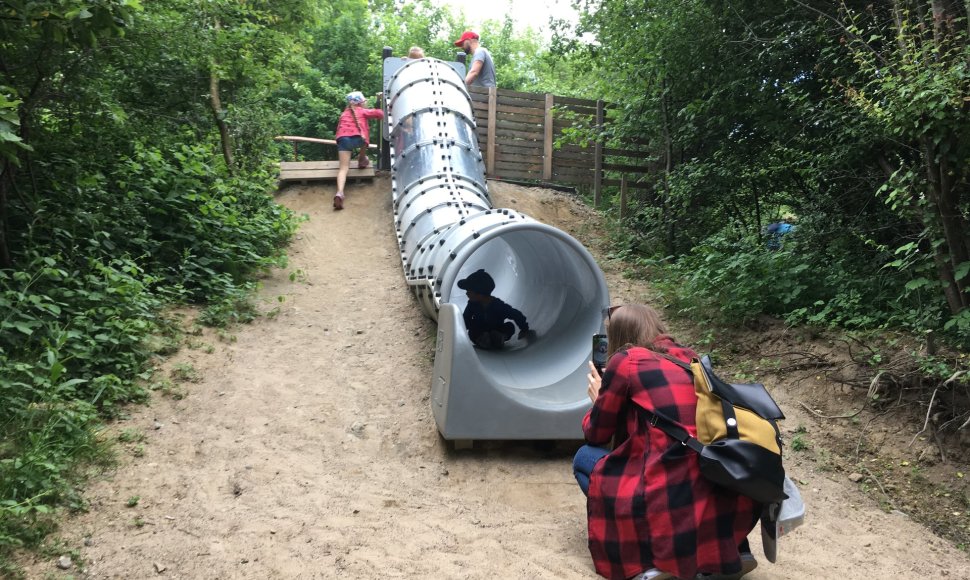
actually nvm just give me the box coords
[583,336,759,579]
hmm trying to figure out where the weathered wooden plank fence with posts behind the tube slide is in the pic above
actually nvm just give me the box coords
[469,87,655,203]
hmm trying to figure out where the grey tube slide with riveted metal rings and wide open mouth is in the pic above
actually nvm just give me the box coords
[384,58,609,440]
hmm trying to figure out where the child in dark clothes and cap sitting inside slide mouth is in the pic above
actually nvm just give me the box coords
[458,269,530,349]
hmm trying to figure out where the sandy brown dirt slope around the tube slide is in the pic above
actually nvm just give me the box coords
[20,179,970,580]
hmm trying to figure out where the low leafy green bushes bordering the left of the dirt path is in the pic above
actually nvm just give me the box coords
[0,143,297,569]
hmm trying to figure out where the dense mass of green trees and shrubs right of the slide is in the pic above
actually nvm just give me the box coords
[564,0,970,340]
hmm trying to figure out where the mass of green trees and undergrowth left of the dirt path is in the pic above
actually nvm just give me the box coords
[0,0,317,564]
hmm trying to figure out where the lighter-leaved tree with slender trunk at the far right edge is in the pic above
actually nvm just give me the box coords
[808,0,970,320]
